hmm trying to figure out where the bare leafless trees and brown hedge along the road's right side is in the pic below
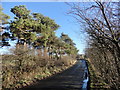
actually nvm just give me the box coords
[67,2,120,89]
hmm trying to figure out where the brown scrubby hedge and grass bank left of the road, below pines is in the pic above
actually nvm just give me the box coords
[2,48,76,89]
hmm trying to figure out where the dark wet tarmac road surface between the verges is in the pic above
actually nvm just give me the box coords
[22,60,86,90]
